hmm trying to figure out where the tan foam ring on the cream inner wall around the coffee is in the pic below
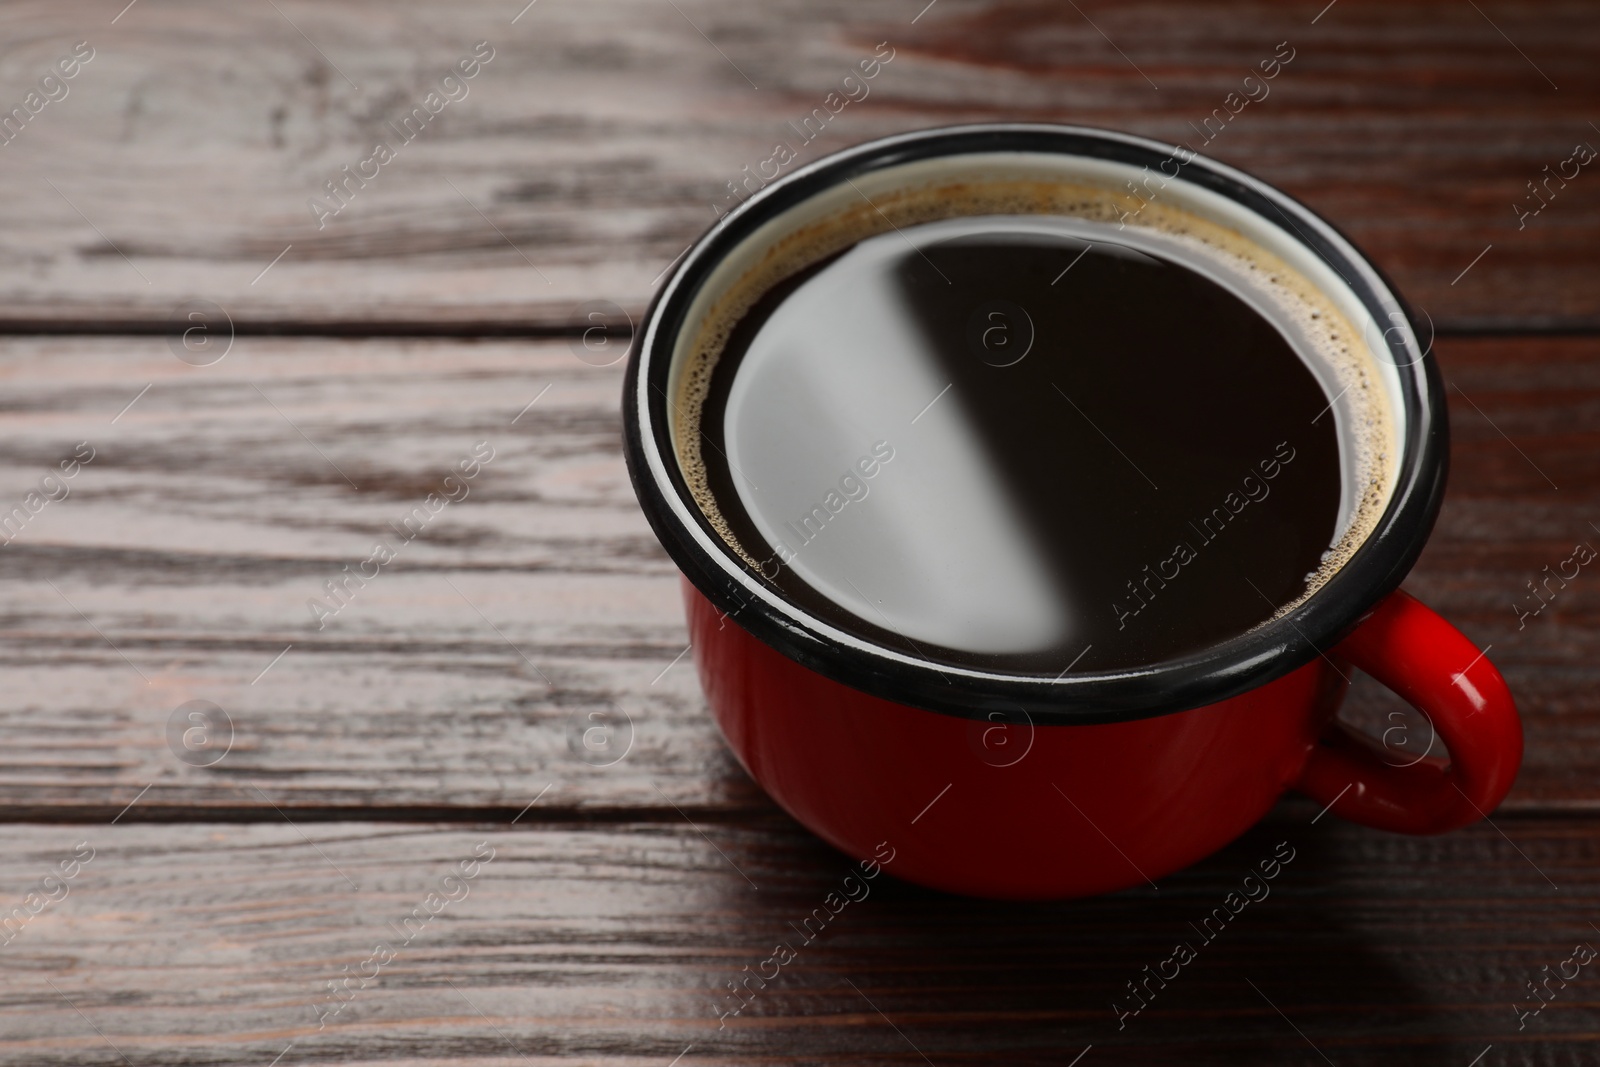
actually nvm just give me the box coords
[669,157,1400,639]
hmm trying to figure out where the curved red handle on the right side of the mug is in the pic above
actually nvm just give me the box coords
[1294,590,1522,833]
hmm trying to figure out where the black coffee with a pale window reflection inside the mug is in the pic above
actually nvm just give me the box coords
[699,216,1350,675]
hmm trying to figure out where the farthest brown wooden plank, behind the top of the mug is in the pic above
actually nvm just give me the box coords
[0,0,1600,331]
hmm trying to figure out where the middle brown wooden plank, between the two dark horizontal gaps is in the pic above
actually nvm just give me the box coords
[0,338,1600,819]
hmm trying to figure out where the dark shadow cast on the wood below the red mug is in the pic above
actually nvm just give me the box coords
[716,800,1470,1067]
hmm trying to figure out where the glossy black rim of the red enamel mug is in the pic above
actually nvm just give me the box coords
[622,123,1450,725]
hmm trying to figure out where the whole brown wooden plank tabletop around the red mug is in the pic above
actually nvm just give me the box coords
[0,0,1600,1067]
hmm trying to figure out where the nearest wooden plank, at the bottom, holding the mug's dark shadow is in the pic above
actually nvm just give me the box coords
[0,805,1600,1067]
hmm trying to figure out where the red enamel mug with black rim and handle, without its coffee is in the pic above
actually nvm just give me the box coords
[624,125,1522,899]
